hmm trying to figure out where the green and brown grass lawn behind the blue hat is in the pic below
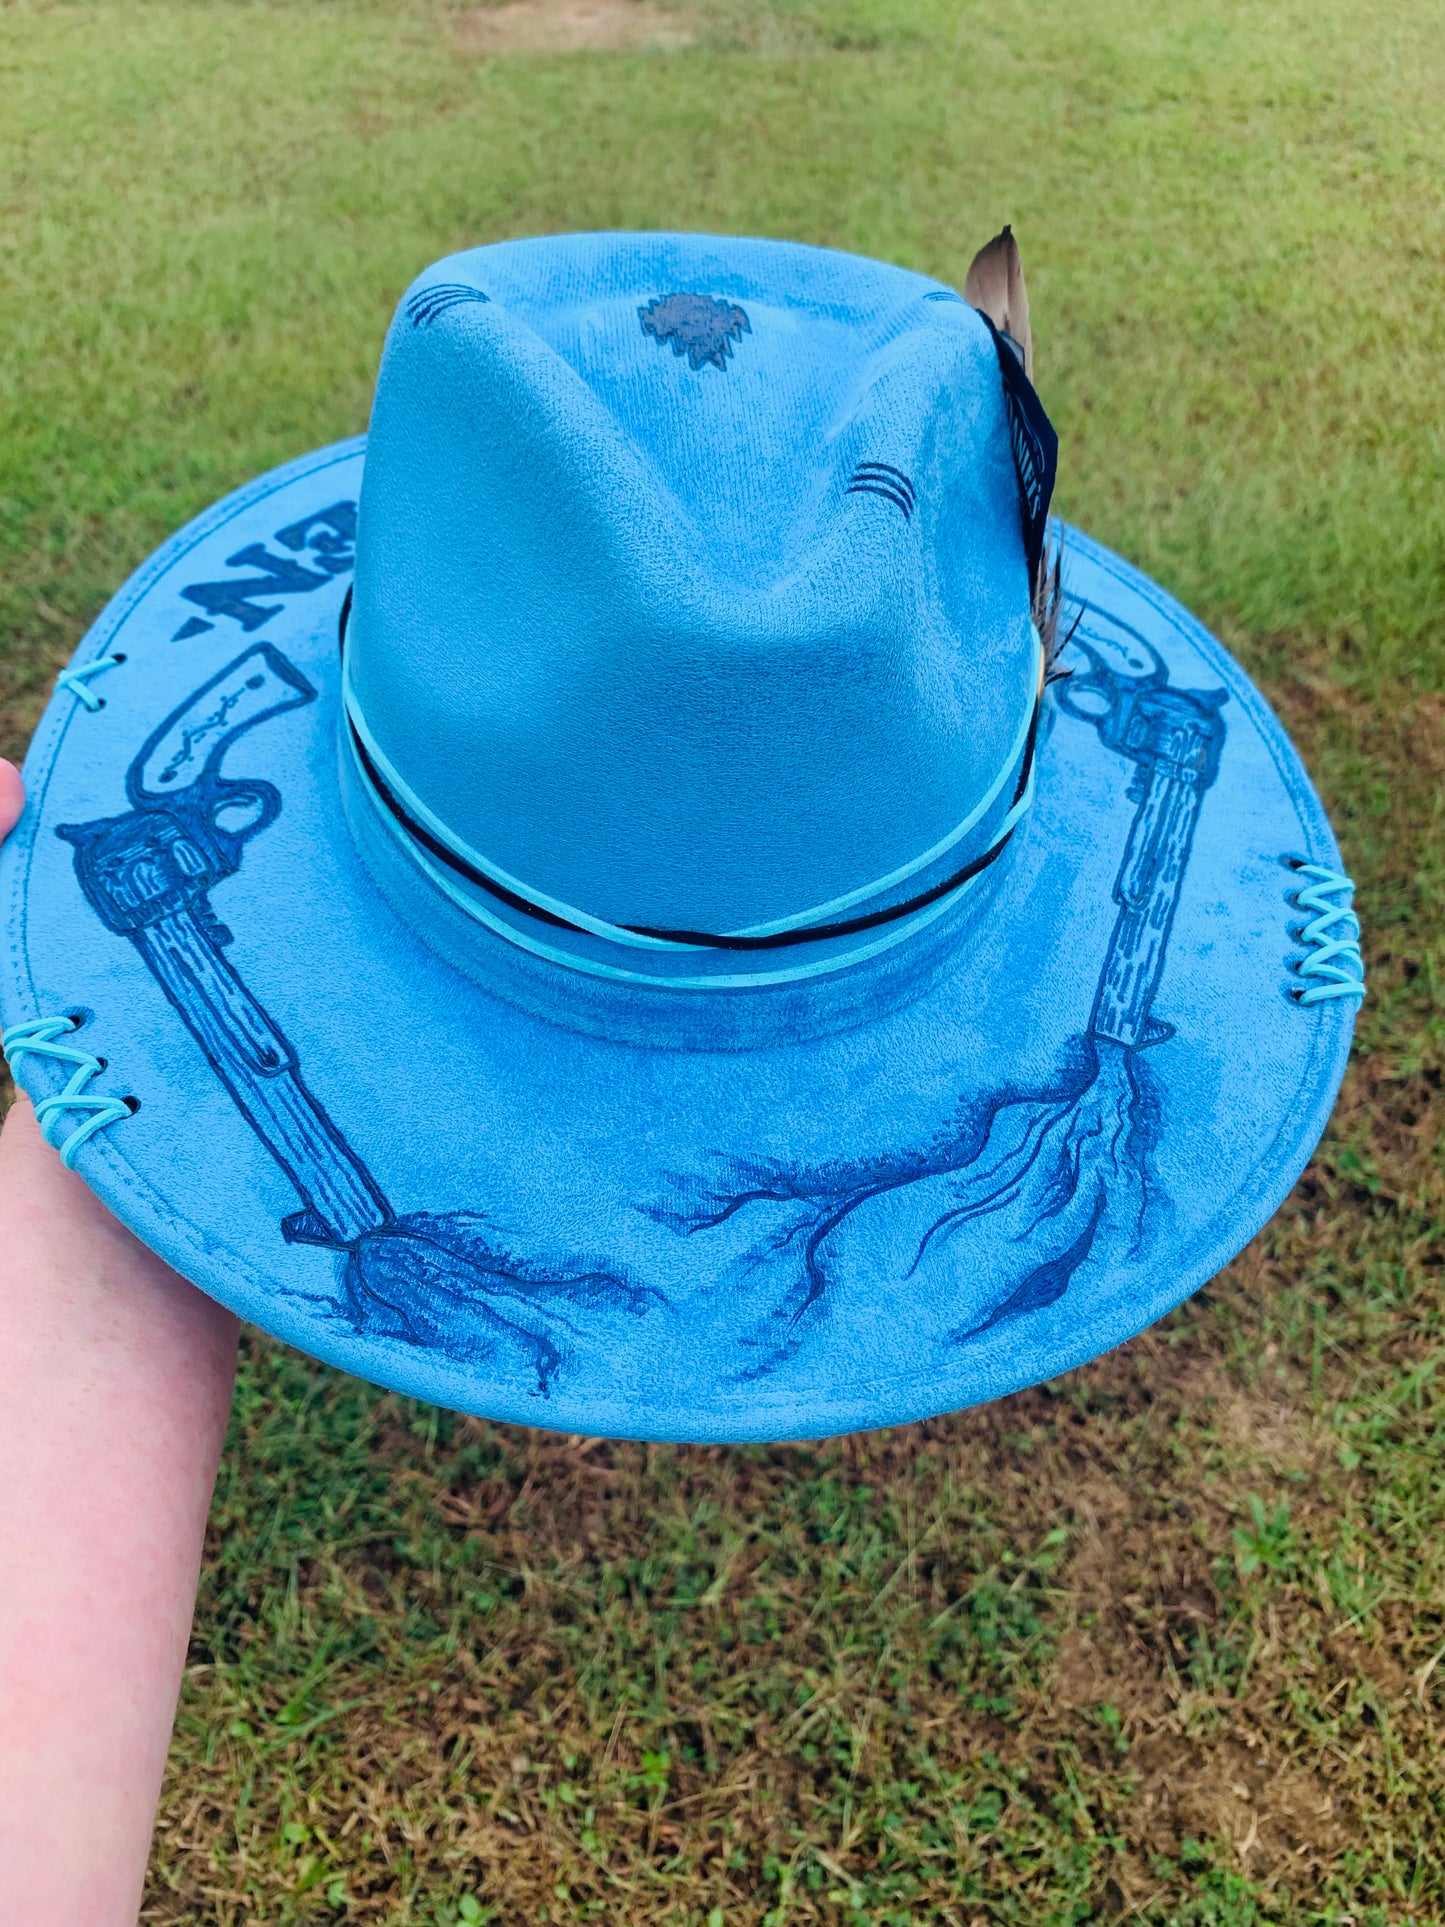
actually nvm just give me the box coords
[0,0,1445,1927]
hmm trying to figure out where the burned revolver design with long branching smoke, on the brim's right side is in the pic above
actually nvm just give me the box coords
[655,609,1225,1376]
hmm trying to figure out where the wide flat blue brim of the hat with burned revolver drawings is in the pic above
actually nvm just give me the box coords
[0,441,1354,1441]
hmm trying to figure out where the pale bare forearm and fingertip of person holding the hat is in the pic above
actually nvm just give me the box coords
[0,761,237,1927]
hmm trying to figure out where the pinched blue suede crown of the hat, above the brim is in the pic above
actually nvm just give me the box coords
[347,235,1046,963]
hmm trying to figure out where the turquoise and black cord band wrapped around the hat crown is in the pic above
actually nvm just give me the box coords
[341,607,1042,990]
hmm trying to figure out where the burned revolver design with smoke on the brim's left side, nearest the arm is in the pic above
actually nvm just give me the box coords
[58,644,663,1395]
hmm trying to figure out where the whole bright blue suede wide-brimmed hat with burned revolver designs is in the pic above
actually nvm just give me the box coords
[0,235,1362,1439]
